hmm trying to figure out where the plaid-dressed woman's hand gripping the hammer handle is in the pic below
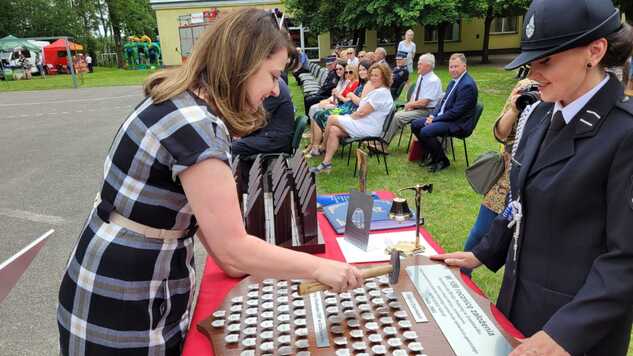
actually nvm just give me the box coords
[313,258,363,293]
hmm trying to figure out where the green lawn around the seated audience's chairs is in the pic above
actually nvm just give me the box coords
[290,66,516,300]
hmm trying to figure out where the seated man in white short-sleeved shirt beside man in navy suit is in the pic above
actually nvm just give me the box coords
[385,52,442,142]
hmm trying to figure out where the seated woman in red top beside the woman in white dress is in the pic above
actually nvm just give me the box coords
[304,62,370,158]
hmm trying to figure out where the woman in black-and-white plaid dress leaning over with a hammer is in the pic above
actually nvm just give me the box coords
[57,9,361,355]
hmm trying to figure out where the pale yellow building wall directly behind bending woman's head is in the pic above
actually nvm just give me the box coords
[156,1,283,66]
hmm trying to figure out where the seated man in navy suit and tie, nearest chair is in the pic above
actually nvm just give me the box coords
[411,53,478,172]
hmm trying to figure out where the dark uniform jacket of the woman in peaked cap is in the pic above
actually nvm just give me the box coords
[473,76,633,355]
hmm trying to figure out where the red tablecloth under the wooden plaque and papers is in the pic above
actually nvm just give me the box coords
[183,192,523,356]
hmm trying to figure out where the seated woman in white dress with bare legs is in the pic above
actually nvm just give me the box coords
[310,64,393,173]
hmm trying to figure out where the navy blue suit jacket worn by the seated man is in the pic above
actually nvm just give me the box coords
[432,72,479,134]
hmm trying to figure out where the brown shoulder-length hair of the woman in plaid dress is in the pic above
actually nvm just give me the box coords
[144,8,298,136]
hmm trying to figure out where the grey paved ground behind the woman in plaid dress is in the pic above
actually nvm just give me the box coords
[0,87,204,356]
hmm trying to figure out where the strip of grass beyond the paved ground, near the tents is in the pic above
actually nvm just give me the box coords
[0,67,154,92]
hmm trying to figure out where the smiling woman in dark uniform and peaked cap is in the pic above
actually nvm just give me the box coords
[436,0,633,356]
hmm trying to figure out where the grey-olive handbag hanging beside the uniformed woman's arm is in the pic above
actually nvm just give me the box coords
[466,151,505,195]
